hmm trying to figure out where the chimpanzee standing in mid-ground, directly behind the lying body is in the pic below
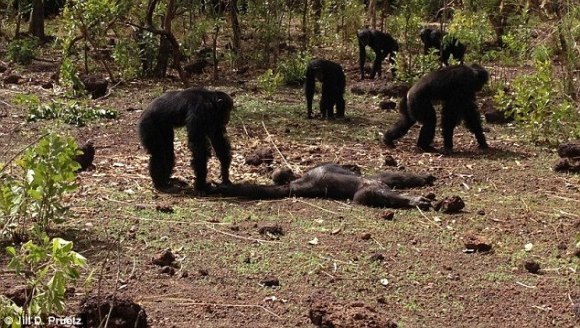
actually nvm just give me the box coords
[304,59,346,119]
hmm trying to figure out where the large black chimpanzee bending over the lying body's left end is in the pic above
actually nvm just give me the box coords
[139,88,233,192]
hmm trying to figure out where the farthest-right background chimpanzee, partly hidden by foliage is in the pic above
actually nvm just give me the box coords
[419,28,466,66]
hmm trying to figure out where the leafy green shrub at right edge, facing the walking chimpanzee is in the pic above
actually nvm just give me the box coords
[494,60,580,143]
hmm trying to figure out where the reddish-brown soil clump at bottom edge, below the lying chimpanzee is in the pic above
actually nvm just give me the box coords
[309,294,397,328]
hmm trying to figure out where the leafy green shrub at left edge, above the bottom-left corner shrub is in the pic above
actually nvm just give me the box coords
[0,134,80,236]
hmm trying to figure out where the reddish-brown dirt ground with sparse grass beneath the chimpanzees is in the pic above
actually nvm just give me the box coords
[0,59,580,328]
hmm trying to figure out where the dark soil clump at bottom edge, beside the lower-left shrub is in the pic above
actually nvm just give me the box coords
[79,295,147,328]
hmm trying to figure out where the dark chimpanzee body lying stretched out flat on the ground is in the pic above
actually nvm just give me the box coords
[215,164,435,209]
